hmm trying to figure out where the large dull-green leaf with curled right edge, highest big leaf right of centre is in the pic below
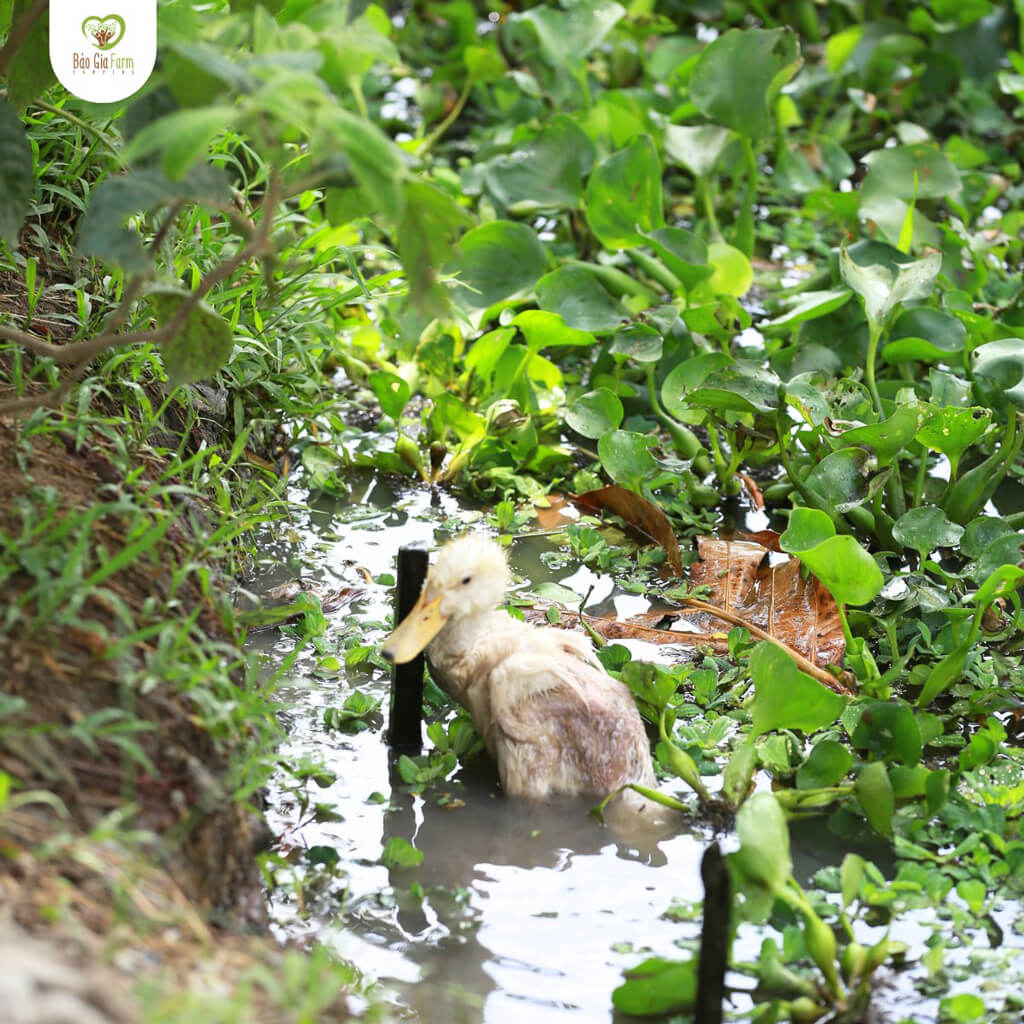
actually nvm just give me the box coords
[690,29,801,140]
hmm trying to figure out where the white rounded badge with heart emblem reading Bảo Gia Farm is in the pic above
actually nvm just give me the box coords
[49,0,157,103]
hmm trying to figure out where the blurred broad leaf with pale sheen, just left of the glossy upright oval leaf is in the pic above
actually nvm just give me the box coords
[483,114,595,214]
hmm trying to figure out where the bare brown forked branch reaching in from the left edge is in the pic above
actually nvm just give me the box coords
[0,172,281,413]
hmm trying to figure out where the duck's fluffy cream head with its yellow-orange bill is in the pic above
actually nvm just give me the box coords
[381,534,509,665]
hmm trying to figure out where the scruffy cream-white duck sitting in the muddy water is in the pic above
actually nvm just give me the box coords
[381,534,655,813]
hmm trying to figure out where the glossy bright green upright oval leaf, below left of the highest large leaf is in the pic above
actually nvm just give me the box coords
[586,135,665,249]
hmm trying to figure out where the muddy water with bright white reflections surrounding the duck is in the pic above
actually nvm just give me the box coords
[253,477,897,1024]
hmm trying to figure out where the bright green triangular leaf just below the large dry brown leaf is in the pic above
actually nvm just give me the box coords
[751,640,847,736]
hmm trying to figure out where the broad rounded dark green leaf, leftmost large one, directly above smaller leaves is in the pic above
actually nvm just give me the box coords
[444,220,548,309]
